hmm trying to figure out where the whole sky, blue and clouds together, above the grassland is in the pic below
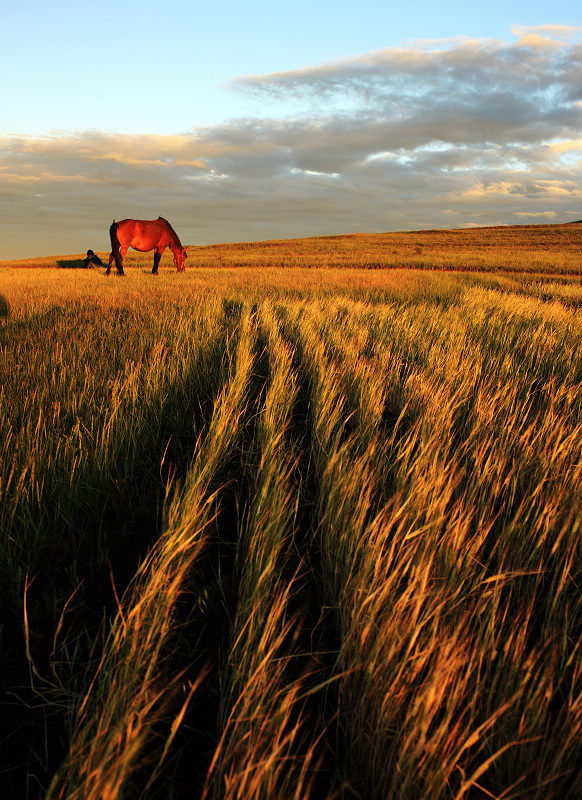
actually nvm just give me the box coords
[0,0,582,259]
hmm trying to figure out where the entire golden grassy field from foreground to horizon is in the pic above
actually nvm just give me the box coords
[0,224,582,800]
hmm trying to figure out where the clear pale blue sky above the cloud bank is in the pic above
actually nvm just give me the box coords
[0,0,582,135]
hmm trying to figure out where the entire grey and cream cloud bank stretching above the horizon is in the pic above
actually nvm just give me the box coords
[0,26,582,258]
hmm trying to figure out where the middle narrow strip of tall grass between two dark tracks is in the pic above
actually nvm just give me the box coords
[203,301,326,800]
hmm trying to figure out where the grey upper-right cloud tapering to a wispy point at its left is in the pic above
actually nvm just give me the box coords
[236,34,582,143]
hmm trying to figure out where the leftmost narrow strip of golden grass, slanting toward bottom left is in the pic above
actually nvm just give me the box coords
[47,306,253,800]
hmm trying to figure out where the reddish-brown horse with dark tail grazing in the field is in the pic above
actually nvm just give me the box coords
[105,217,187,275]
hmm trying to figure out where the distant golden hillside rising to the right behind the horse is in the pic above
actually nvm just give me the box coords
[0,221,582,275]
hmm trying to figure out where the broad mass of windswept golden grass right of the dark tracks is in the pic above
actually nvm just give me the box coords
[290,295,581,797]
